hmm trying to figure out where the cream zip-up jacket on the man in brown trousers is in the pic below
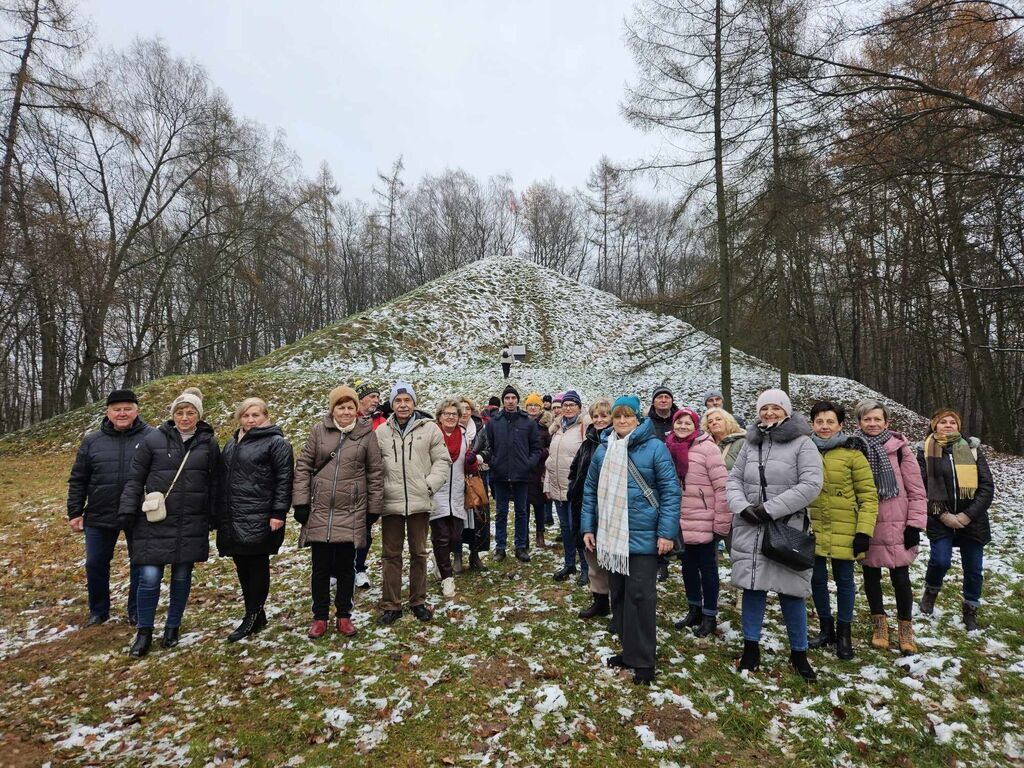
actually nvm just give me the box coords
[377,412,452,517]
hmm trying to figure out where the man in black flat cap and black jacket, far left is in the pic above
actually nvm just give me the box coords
[68,389,153,627]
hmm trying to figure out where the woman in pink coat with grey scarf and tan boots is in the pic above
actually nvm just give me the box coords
[855,399,928,653]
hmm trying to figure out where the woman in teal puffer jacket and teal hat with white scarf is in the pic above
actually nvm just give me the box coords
[582,395,681,685]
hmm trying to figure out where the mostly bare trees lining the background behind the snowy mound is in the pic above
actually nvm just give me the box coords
[0,0,1024,450]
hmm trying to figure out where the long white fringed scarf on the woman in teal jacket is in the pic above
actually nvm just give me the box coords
[597,430,633,575]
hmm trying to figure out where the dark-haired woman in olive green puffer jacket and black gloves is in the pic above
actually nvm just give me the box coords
[808,400,879,659]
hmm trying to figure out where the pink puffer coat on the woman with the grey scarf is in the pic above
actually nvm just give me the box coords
[863,432,928,568]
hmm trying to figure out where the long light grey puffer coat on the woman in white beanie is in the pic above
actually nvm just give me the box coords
[726,414,822,597]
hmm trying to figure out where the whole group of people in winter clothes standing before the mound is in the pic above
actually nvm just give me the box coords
[68,381,993,683]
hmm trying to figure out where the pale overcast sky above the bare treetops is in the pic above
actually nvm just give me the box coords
[78,0,657,200]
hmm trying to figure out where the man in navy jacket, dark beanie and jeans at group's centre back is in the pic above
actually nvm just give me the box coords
[474,385,542,562]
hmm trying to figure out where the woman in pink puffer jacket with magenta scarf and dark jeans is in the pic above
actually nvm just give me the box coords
[665,408,732,637]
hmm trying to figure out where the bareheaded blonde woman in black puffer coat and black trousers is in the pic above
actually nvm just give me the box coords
[217,397,293,643]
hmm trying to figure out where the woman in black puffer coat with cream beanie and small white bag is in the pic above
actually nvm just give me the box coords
[119,387,220,656]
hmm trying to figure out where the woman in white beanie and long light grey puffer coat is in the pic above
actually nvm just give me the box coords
[726,389,823,681]
